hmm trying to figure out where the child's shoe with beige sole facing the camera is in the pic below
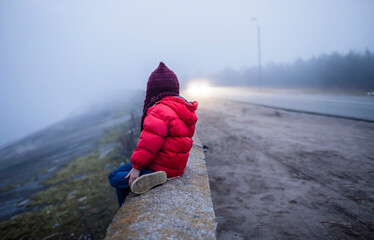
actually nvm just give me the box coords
[130,171,167,194]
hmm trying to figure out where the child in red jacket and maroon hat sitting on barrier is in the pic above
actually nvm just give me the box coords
[108,62,198,207]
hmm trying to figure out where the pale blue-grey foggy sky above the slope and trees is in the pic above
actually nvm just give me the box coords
[0,0,374,145]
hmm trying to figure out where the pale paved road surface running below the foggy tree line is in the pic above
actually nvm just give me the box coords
[213,88,374,121]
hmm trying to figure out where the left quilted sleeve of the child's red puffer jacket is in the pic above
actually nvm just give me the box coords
[131,110,168,170]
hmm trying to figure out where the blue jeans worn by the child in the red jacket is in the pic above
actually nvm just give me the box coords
[108,162,154,207]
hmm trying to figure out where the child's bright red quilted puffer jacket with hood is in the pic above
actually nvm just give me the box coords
[131,97,198,177]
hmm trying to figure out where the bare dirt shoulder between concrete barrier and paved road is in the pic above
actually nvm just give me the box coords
[197,99,374,239]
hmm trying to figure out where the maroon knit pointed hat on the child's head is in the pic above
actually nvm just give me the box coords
[140,62,179,130]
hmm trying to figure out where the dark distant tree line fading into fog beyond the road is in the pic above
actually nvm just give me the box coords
[212,50,374,91]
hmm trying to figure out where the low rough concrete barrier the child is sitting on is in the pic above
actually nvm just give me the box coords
[105,137,217,240]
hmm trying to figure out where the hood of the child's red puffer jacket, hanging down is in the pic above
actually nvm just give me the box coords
[160,96,198,126]
